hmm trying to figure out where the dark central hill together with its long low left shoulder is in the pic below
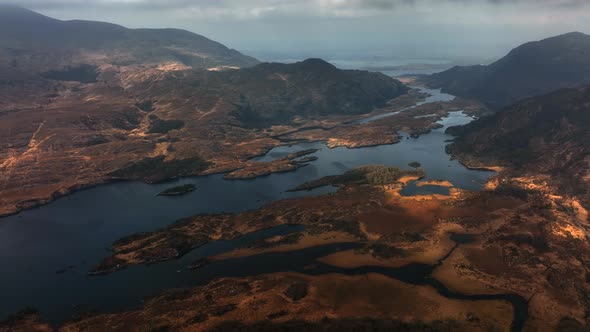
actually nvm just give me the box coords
[137,59,409,128]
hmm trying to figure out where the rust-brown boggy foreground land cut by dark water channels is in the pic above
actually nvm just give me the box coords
[15,162,572,331]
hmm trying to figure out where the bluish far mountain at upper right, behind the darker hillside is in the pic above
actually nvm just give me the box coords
[424,32,590,110]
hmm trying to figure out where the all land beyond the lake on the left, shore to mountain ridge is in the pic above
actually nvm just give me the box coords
[0,5,419,216]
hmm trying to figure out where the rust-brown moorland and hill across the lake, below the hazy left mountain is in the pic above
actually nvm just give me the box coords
[0,60,418,215]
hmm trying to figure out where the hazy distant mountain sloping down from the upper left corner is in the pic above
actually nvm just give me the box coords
[0,5,258,69]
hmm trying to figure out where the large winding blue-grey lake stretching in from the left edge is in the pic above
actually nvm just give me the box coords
[0,87,500,321]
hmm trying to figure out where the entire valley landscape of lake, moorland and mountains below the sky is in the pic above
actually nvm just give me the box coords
[0,4,590,332]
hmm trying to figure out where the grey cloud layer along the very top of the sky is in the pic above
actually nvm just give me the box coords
[0,0,590,30]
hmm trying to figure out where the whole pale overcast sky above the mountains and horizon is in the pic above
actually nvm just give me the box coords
[0,0,590,58]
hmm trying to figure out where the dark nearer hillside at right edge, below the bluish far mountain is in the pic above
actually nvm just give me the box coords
[449,86,590,206]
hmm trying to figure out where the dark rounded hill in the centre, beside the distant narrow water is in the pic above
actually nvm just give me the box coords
[201,59,409,127]
